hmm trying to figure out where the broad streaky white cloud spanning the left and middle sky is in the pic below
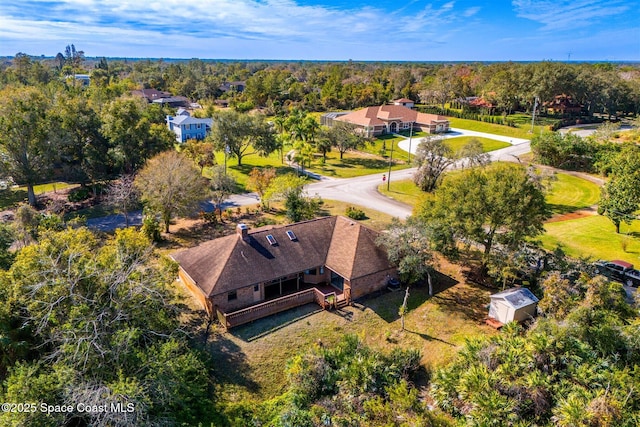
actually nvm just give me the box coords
[0,0,476,55]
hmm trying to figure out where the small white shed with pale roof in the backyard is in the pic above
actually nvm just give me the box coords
[489,288,538,324]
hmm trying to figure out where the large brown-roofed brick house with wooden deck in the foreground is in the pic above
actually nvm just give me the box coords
[172,216,396,327]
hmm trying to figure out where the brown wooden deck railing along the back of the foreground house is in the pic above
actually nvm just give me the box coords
[217,288,337,328]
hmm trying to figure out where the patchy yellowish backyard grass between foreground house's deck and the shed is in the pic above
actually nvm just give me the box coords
[208,265,496,401]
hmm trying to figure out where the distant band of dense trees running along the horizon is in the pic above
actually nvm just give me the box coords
[0,53,640,116]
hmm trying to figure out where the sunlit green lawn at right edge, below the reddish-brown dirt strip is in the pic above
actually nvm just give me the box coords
[540,215,640,265]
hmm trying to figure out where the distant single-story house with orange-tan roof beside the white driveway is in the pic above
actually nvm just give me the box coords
[327,105,449,137]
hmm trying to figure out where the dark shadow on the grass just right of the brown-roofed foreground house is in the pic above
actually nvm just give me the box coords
[359,271,458,323]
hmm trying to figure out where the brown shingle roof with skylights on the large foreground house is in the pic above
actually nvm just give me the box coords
[173,216,390,296]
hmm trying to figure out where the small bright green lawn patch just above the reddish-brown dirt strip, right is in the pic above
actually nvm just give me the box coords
[547,173,600,214]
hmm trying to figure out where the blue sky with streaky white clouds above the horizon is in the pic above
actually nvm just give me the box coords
[0,0,640,61]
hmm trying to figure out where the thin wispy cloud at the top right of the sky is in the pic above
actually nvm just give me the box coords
[512,0,629,30]
